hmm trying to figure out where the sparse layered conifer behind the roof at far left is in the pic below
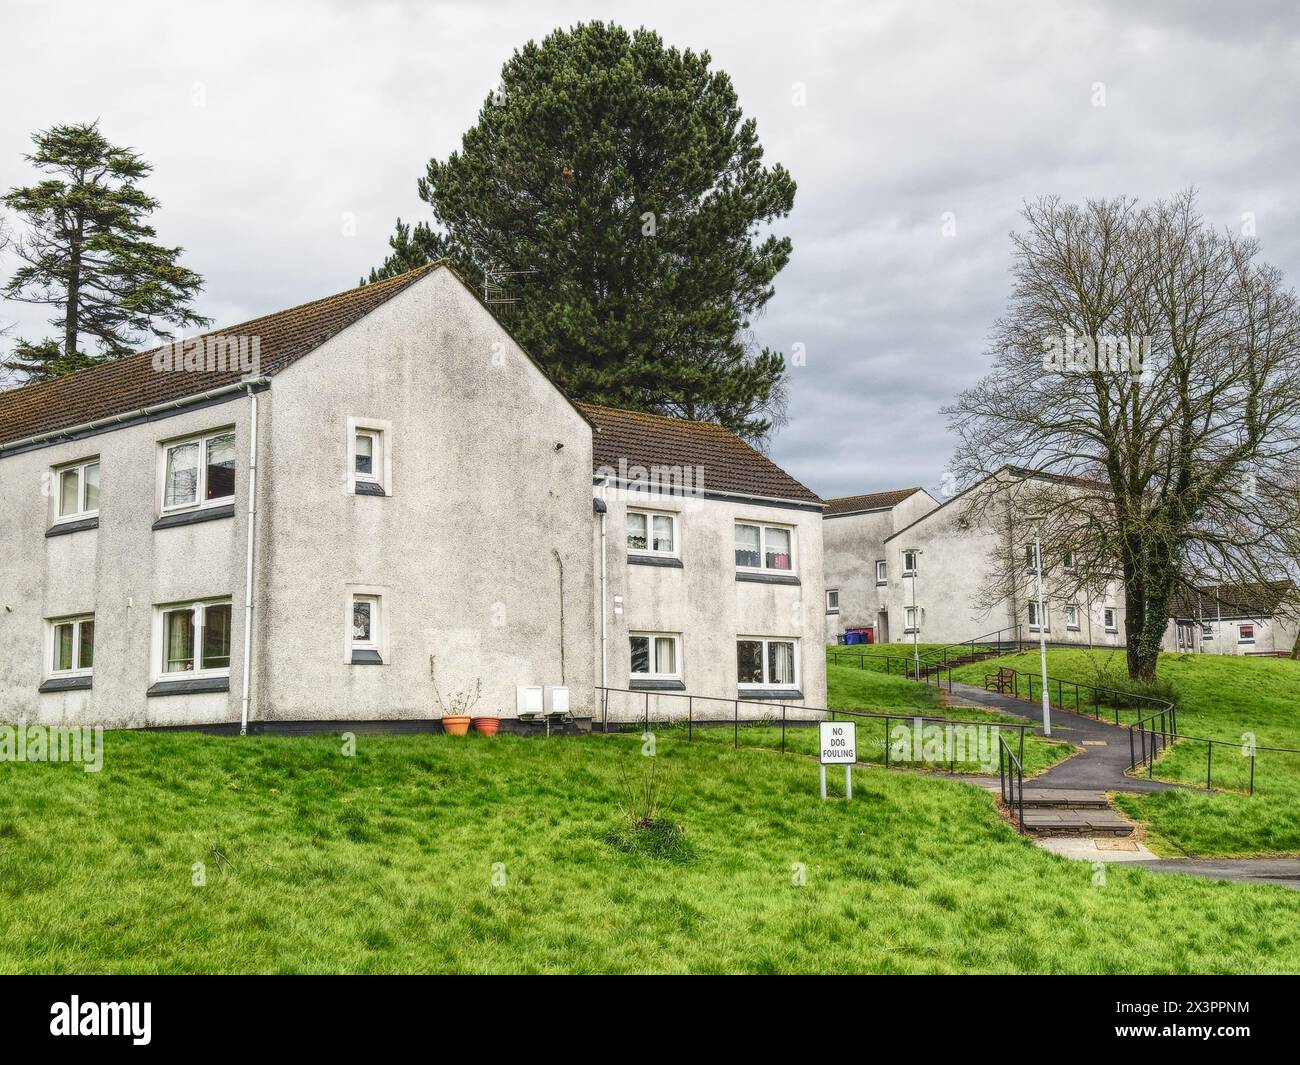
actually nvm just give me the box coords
[0,122,208,381]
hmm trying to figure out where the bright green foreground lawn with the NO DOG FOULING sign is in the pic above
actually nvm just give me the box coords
[0,732,1300,973]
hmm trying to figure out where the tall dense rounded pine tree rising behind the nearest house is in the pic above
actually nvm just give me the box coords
[371,22,794,438]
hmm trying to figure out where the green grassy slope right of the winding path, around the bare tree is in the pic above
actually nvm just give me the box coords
[956,650,1300,856]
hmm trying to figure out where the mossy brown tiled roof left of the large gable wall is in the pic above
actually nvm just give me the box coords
[0,264,437,445]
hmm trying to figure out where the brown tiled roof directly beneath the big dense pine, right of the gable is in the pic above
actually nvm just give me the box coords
[577,403,822,503]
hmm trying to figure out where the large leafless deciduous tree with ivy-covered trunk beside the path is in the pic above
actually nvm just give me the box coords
[944,191,1300,680]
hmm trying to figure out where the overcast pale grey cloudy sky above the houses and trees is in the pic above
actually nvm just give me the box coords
[0,0,1300,497]
